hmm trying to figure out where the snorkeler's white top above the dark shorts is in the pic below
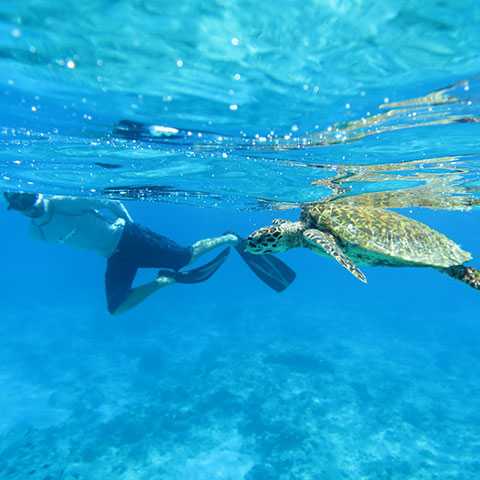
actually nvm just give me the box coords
[30,196,132,257]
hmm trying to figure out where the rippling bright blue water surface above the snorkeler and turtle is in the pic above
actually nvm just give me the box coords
[0,0,480,208]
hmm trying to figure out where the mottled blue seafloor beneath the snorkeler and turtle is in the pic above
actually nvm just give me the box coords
[0,303,480,480]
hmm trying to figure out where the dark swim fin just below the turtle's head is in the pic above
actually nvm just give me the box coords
[235,240,297,292]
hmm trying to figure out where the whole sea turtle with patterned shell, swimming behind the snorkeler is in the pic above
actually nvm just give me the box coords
[246,200,480,289]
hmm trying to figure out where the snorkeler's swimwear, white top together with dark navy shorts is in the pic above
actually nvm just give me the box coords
[26,196,192,313]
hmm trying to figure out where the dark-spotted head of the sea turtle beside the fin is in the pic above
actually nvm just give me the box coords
[245,221,301,255]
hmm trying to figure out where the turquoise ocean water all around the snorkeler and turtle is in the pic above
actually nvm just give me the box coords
[0,0,480,480]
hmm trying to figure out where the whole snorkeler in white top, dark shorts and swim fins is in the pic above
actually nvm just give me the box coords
[4,192,295,314]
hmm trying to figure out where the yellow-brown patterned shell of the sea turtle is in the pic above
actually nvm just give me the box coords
[302,202,471,268]
